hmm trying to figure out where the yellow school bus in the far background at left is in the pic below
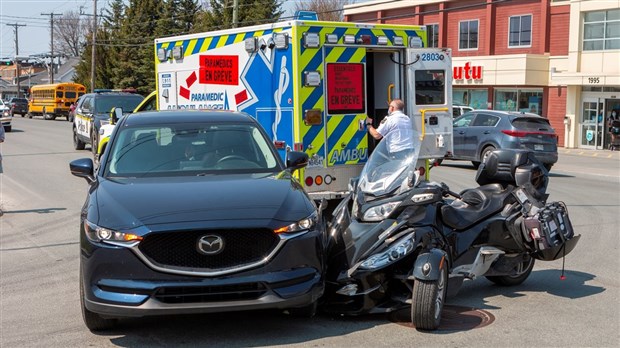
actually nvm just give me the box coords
[28,82,86,121]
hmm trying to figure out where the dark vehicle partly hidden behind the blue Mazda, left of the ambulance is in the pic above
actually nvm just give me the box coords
[68,91,144,156]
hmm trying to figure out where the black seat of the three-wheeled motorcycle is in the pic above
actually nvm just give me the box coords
[441,184,512,231]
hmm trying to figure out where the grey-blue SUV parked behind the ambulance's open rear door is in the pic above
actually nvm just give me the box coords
[447,110,558,169]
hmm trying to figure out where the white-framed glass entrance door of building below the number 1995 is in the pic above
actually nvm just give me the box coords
[579,98,605,149]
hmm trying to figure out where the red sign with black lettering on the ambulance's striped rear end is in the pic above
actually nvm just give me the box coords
[327,63,366,115]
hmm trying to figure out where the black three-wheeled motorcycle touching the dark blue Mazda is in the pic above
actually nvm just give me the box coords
[324,135,580,330]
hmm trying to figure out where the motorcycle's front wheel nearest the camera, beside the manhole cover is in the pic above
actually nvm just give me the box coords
[411,266,448,330]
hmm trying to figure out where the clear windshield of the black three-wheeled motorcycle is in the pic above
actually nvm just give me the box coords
[357,131,420,196]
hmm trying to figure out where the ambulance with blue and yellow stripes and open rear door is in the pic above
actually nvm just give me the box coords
[155,20,452,200]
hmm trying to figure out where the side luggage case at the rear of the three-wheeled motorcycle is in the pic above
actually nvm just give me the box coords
[522,202,581,261]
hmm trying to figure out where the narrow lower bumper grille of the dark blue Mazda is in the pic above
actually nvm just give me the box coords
[154,283,267,303]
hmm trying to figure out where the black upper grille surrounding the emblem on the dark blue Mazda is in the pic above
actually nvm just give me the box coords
[139,229,279,272]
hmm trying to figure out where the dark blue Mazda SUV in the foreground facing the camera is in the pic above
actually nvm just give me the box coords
[70,110,326,330]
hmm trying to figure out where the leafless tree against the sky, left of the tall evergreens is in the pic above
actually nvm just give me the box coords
[54,11,92,57]
